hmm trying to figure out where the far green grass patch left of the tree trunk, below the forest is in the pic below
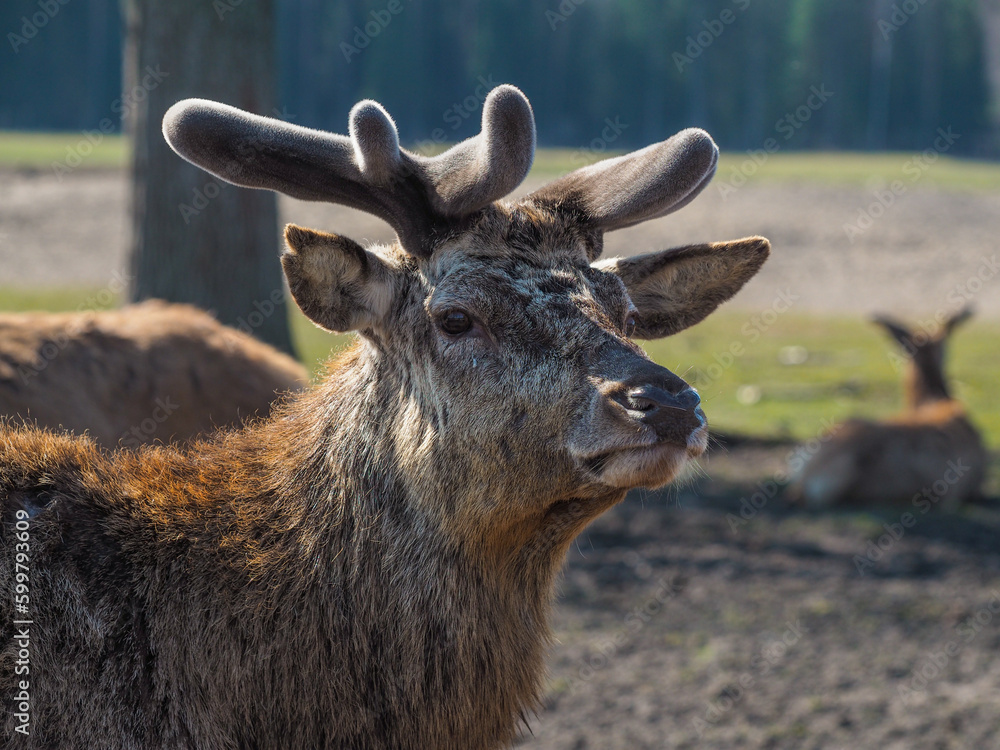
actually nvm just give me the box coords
[0,131,128,169]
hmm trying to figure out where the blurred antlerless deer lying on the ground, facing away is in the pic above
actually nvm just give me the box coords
[792,307,987,513]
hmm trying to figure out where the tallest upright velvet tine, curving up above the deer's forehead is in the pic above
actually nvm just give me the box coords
[422,85,535,216]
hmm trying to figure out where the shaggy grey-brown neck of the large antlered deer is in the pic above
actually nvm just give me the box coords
[252,351,584,721]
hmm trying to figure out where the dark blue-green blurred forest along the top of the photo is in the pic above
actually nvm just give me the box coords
[0,0,997,156]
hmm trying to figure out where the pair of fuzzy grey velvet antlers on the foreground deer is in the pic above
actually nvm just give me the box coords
[163,85,719,260]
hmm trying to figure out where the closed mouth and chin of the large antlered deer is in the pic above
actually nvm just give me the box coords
[577,425,708,489]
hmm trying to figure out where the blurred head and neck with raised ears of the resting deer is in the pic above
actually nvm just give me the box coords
[872,306,974,409]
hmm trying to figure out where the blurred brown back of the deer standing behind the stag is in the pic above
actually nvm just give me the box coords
[0,300,309,448]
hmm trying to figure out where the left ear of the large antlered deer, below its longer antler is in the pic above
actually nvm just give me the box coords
[281,224,395,333]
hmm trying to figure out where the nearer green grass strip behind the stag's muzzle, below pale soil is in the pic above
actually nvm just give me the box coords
[0,288,1000,448]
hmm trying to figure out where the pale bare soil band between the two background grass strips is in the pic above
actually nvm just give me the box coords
[0,170,1000,318]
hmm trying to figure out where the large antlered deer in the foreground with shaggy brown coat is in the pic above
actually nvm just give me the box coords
[0,85,770,750]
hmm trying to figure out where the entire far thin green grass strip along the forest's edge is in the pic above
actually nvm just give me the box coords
[0,131,1000,190]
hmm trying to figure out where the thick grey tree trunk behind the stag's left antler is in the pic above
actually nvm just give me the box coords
[124,0,292,352]
